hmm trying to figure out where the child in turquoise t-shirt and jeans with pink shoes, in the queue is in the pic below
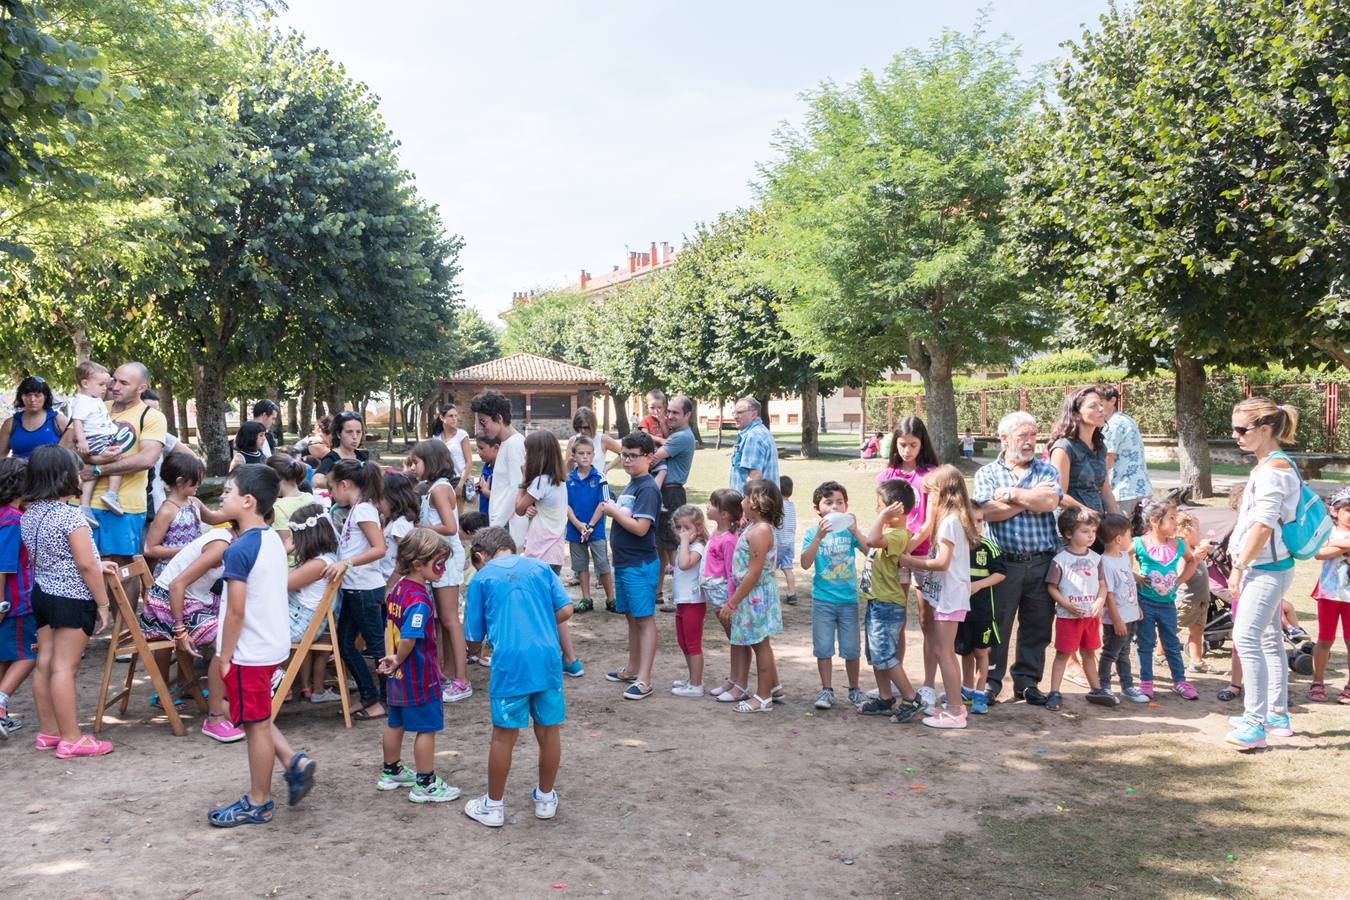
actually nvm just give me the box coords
[1134,501,1200,700]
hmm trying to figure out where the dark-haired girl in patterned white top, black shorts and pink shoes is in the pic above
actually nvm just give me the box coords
[19,444,117,760]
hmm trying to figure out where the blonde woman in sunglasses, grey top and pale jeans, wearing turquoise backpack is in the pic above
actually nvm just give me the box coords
[1227,397,1301,750]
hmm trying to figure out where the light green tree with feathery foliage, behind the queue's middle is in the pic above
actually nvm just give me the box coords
[760,31,1046,460]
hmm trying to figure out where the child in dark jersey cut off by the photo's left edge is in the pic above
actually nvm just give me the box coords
[0,456,38,739]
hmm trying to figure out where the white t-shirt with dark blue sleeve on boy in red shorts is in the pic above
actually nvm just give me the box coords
[216,528,290,665]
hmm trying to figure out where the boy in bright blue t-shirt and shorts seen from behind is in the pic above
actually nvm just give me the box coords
[464,528,572,828]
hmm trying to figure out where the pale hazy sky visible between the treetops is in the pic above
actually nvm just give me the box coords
[277,0,1107,317]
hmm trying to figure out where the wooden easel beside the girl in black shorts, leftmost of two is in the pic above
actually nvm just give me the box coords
[93,556,207,737]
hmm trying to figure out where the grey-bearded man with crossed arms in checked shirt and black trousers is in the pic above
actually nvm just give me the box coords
[972,412,1064,706]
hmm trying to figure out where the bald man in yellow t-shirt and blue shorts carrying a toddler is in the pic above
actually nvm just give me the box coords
[84,363,169,563]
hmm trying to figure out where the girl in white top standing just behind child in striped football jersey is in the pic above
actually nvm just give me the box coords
[408,439,474,703]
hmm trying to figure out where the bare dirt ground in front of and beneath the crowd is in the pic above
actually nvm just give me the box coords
[0,453,1350,897]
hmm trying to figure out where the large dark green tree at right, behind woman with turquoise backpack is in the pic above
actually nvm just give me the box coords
[1010,0,1350,497]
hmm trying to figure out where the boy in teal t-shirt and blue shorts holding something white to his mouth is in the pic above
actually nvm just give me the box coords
[802,482,867,710]
